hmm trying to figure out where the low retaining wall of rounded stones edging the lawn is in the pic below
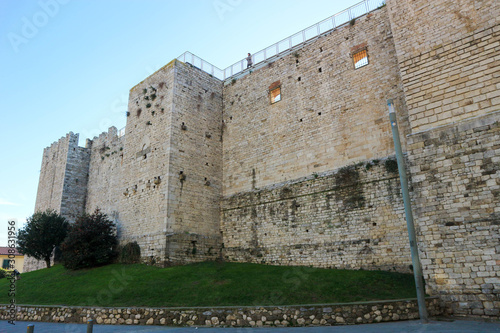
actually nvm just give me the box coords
[0,298,442,327]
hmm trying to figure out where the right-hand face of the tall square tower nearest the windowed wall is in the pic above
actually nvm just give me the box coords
[161,61,222,262]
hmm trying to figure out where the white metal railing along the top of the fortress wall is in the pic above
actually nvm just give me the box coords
[177,0,385,81]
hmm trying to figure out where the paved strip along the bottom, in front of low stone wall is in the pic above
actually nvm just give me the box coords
[0,319,500,333]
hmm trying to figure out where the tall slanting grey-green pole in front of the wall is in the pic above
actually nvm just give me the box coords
[387,99,429,323]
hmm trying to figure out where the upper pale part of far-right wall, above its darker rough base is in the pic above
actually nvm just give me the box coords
[388,0,500,133]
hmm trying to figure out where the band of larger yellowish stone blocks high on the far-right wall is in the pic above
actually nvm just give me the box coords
[392,25,500,132]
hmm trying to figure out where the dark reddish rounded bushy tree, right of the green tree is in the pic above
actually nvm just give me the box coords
[61,209,118,269]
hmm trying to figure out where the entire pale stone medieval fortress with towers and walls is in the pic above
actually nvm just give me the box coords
[26,0,500,318]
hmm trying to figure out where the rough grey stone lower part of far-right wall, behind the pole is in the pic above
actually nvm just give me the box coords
[408,112,500,317]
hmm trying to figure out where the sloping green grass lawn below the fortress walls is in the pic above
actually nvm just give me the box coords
[0,262,416,307]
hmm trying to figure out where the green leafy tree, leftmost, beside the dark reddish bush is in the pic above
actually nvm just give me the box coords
[17,209,69,268]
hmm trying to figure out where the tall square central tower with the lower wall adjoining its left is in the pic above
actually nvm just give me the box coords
[87,60,222,265]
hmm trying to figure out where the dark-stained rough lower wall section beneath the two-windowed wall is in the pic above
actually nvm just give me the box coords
[221,158,411,272]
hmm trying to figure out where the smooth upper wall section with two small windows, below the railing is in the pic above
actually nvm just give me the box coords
[223,7,407,197]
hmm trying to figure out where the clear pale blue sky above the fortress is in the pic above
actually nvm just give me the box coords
[0,0,368,246]
